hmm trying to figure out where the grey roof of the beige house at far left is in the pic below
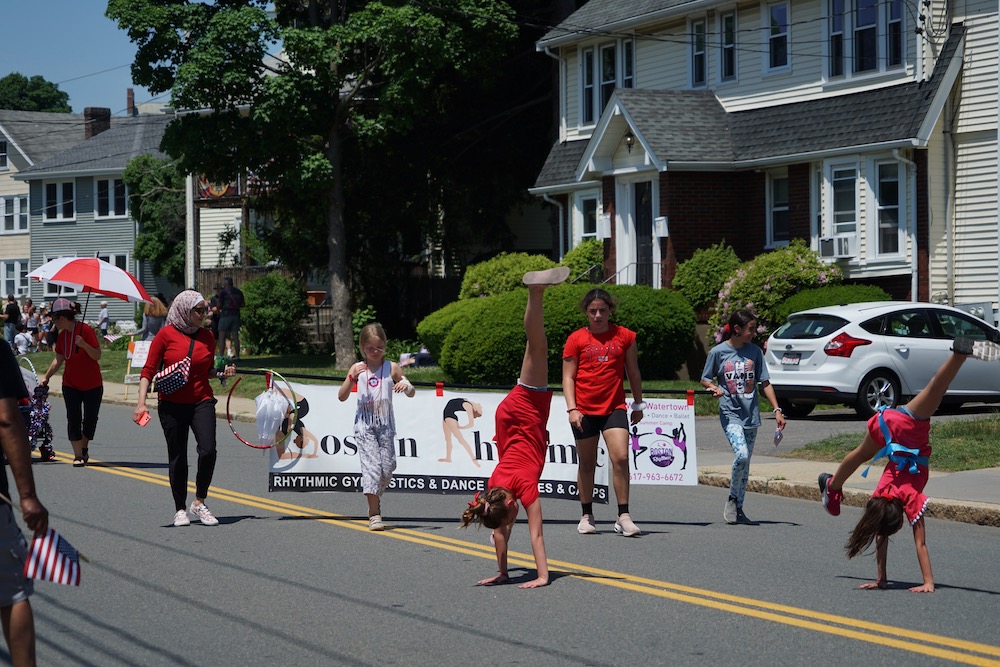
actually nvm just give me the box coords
[0,109,85,164]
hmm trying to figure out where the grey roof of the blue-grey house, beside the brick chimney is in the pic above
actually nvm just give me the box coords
[15,116,173,181]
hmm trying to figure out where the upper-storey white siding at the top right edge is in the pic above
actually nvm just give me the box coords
[955,11,997,134]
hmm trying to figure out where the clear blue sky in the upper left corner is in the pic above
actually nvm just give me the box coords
[0,0,159,116]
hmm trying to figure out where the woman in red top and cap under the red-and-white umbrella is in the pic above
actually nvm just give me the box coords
[40,297,104,468]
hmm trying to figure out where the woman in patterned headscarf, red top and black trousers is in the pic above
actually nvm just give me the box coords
[132,290,236,526]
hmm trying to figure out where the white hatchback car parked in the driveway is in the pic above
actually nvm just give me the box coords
[764,301,1000,418]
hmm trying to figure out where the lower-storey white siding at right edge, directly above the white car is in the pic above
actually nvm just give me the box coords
[954,134,998,303]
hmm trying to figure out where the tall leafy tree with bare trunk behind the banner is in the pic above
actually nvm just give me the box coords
[107,0,517,366]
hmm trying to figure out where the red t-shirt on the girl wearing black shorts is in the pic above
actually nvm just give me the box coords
[563,324,635,416]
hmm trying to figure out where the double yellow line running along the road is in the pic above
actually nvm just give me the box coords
[72,454,1000,667]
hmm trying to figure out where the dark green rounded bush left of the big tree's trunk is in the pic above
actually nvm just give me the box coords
[241,273,309,354]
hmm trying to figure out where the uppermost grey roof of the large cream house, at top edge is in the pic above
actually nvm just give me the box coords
[536,0,704,50]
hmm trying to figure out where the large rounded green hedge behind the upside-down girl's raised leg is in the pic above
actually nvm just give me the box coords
[434,285,695,386]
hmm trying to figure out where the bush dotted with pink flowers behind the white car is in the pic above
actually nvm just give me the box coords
[708,239,844,342]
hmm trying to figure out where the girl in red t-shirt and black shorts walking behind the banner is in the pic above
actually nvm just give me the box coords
[563,289,646,537]
